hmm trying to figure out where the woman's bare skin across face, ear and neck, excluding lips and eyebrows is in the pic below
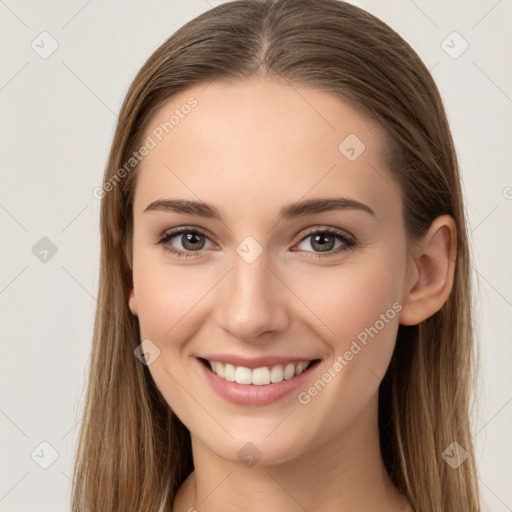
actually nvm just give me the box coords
[129,78,455,512]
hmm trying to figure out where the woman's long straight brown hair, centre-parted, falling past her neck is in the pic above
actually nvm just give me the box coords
[72,0,480,512]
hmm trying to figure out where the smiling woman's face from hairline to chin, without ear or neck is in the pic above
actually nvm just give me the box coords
[129,78,408,463]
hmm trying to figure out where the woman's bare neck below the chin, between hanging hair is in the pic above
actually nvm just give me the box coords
[173,395,411,512]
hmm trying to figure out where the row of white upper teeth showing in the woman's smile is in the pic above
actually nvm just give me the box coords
[208,360,310,386]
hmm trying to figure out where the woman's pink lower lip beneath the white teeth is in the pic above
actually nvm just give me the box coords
[196,359,318,405]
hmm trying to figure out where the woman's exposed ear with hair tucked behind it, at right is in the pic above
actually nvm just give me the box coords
[400,215,457,325]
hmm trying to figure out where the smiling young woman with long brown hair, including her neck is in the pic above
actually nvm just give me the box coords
[73,0,480,512]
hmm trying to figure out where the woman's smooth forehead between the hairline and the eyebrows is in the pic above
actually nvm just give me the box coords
[135,78,399,220]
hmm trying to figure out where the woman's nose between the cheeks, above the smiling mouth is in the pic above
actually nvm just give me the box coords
[216,252,290,342]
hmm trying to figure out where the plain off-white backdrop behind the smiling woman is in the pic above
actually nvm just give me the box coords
[0,0,512,512]
